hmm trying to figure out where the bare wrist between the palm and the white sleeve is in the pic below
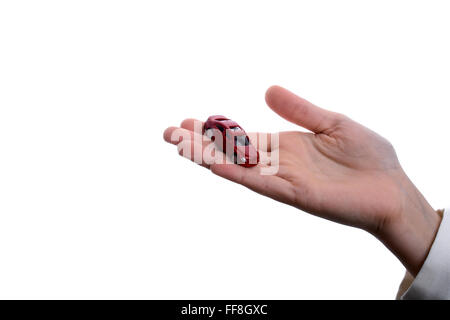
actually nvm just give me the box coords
[376,175,442,276]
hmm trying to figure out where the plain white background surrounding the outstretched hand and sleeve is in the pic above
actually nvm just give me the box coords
[0,0,450,299]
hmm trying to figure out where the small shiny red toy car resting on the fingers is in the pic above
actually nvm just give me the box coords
[203,116,259,167]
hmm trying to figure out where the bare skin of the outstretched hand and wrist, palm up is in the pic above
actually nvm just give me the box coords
[164,86,441,276]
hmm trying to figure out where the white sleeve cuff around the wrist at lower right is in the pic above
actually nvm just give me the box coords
[400,209,450,300]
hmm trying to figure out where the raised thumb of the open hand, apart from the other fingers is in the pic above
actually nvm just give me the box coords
[266,86,342,133]
